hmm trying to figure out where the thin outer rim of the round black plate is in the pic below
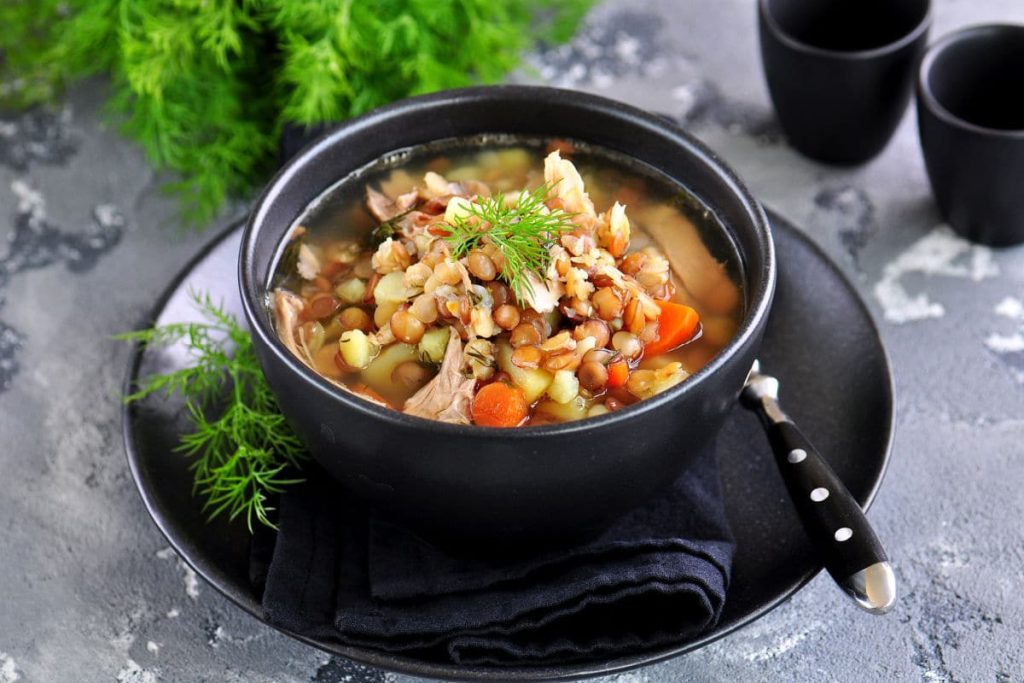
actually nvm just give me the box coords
[121,204,896,681]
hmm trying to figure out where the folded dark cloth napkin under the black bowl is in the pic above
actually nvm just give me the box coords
[253,452,733,665]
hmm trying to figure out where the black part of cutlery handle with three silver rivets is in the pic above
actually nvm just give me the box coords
[767,420,889,584]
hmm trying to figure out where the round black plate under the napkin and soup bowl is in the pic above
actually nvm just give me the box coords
[124,214,893,681]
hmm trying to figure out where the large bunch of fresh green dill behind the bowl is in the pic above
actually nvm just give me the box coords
[0,0,594,227]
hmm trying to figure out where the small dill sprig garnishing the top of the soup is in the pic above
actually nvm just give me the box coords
[444,183,575,303]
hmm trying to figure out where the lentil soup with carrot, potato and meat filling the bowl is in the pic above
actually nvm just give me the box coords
[269,138,743,427]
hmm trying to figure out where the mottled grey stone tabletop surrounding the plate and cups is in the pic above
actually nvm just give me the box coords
[0,0,1024,683]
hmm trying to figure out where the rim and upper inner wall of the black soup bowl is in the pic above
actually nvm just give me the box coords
[238,85,776,441]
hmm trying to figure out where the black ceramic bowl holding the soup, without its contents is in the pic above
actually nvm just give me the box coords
[239,86,775,543]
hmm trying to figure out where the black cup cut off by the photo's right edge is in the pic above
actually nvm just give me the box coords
[918,25,1024,247]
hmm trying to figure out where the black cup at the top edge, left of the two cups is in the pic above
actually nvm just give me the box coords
[758,0,932,164]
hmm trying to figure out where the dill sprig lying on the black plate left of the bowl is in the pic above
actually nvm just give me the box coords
[116,293,307,530]
